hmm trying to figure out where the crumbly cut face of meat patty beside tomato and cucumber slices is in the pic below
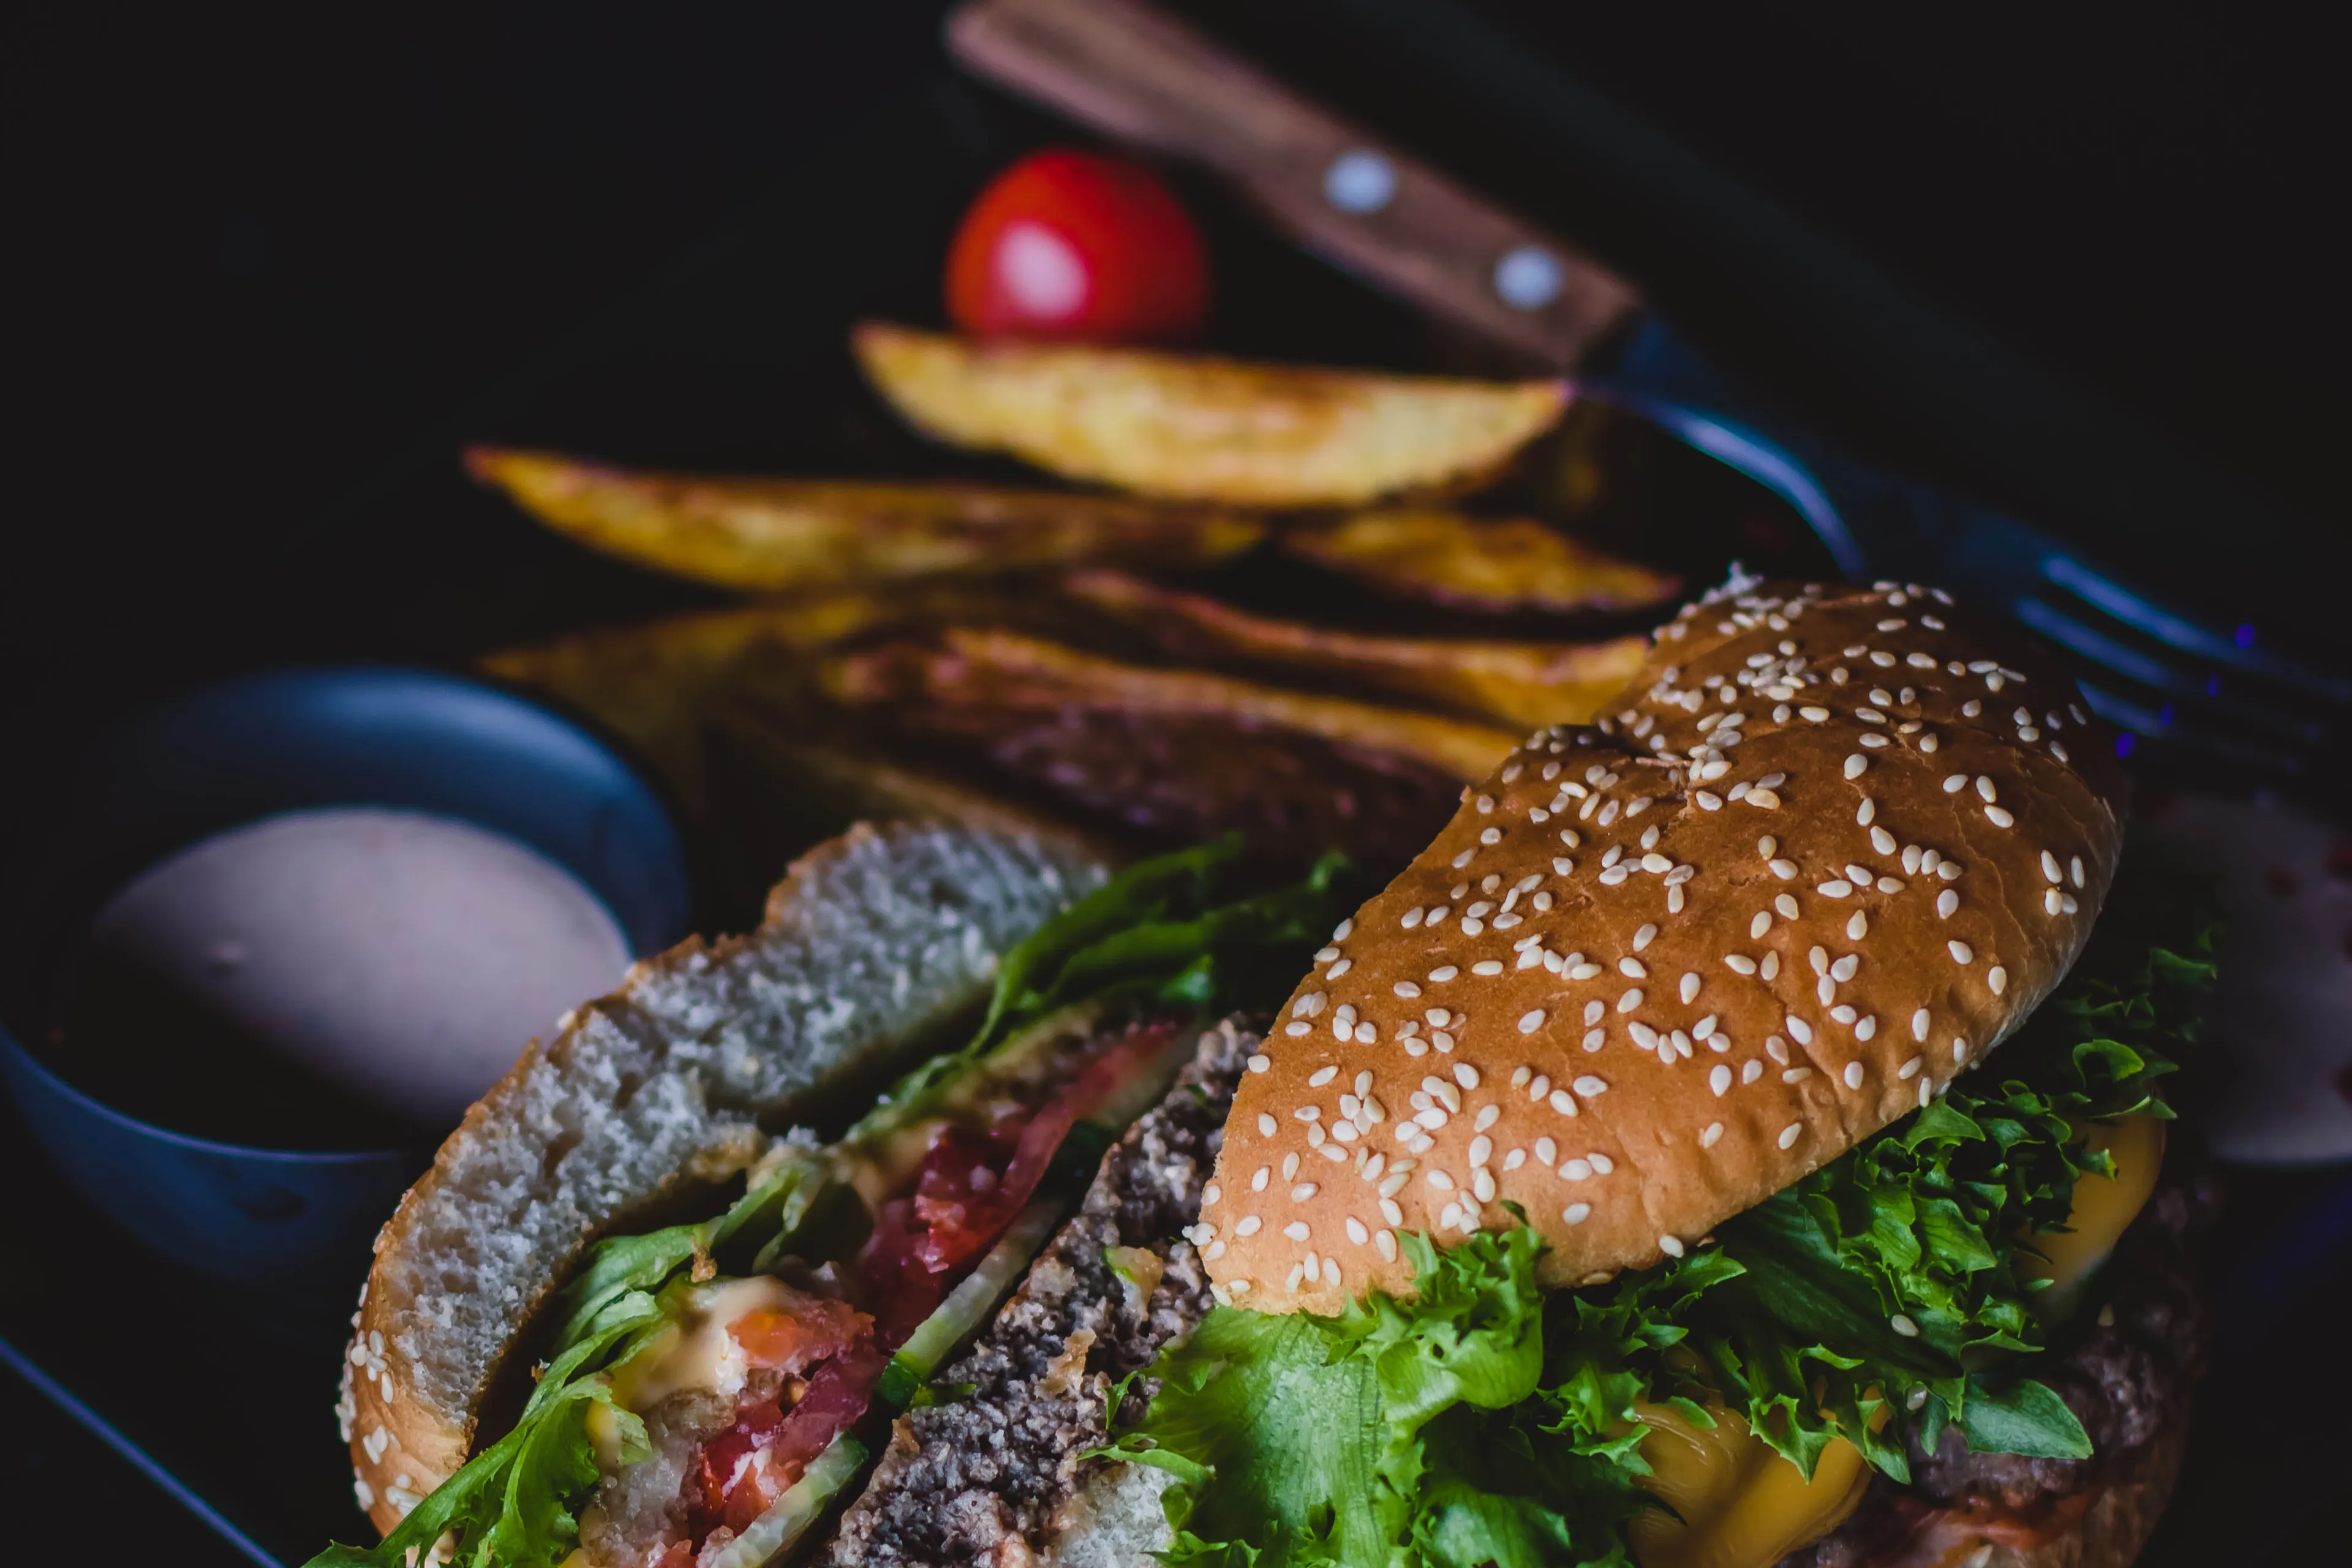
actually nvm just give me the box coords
[828,1023,1258,1568]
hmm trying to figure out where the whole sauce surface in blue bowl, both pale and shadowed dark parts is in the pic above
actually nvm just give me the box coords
[64,806,630,1147]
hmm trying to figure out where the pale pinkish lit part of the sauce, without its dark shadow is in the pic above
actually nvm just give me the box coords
[92,806,628,1126]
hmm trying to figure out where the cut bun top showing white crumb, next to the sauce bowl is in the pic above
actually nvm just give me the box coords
[339,825,1103,1531]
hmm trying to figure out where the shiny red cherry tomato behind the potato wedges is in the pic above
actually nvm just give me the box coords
[948,148,1209,343]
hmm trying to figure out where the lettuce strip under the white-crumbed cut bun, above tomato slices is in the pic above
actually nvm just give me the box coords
[306,837,1352,1568]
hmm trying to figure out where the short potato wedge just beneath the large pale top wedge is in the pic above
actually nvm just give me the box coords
[1280,508,1682,611]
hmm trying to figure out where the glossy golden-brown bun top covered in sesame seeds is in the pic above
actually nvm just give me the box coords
[1202,583,2122,1312]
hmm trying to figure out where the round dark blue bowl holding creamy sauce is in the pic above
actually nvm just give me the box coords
[0,665,692,1300]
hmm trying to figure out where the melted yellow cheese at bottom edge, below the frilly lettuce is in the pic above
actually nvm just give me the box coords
[1630,1403,1870,1568]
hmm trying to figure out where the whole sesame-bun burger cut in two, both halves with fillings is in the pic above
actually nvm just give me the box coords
[317,581,2211,1568]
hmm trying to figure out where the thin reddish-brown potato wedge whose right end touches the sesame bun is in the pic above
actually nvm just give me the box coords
[1063,569,1649,729]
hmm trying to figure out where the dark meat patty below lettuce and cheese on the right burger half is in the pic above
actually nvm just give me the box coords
[1781,1173,2218,1568]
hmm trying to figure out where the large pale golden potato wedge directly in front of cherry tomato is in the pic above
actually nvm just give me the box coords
[854,322,1569,505]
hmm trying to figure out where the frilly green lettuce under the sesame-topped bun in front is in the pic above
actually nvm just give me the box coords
[1106,870,2213,1568]
